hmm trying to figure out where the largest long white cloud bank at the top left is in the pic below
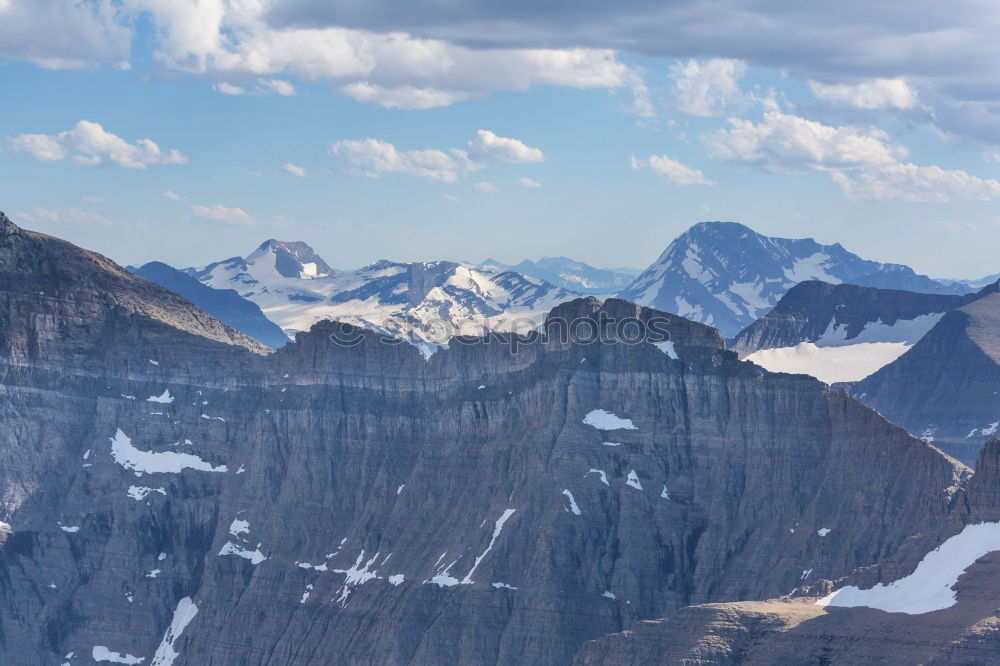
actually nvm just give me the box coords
[117,0,642,109]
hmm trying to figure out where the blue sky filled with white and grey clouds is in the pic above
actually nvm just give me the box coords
[0,0,1000,277]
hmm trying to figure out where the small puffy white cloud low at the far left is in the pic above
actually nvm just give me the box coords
[9,120,188,169]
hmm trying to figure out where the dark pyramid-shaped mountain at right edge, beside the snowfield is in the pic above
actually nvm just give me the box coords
[850,283,1000,463]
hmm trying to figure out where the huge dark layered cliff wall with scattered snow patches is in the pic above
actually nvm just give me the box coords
[0,215,968,666]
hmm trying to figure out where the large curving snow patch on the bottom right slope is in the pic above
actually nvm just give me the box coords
[816,522,1000,615]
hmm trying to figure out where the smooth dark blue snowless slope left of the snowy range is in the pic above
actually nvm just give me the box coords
[130,261,288,349]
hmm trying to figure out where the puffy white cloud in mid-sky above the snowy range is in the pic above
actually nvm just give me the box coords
[330,130,545,183]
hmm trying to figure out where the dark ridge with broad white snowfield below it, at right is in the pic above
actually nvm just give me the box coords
[729,281,976,384]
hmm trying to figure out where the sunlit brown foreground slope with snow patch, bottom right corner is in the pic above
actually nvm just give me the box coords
[574,439,1000,666]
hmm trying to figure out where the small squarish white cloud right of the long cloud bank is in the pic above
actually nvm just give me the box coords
[670,58,747,117]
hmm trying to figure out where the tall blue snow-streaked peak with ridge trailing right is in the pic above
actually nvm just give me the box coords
[618,222,968,337]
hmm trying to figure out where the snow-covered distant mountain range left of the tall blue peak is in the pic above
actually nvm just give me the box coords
[186,241,579,352]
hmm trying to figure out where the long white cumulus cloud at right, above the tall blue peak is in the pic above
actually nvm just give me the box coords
[704,111,1000,202]
